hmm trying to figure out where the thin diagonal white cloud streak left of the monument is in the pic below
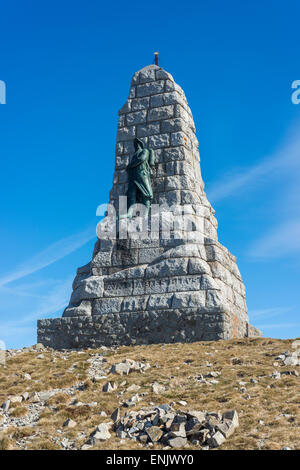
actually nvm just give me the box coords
[0,226,96,286]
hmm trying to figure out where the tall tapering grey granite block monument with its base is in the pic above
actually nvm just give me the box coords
[38,65,261,348]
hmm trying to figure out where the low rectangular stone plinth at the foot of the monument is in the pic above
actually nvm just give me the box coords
[38,309,260,349]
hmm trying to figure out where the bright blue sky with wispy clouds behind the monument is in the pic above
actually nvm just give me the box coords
[0,0,300,347]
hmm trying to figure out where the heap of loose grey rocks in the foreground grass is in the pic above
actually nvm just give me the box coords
[110,404,239,449]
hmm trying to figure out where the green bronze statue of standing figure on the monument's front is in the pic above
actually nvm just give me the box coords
[127,138,154,218]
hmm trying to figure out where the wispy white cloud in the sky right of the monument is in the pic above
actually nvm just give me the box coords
[208,123,300,259]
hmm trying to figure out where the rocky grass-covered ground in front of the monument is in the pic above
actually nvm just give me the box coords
[0,338,300,450]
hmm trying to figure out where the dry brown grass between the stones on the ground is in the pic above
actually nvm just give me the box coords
[0,338,300,450]
